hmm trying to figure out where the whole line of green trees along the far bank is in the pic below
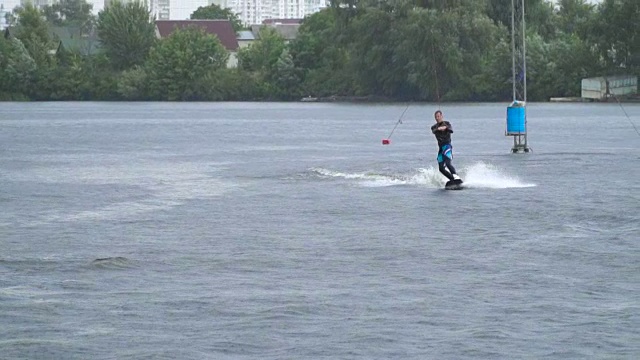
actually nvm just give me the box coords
[0,0,640,101]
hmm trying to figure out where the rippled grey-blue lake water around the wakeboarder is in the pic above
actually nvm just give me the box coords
[0,103,640,359]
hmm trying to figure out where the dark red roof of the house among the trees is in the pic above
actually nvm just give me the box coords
[156,20,238,51]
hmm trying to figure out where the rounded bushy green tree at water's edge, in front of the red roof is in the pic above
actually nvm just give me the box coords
[145,27,229,101]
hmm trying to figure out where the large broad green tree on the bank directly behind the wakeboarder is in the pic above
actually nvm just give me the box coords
[396,7,500,101]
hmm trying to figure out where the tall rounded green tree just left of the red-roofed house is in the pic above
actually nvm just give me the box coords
[97,1,156,69]
